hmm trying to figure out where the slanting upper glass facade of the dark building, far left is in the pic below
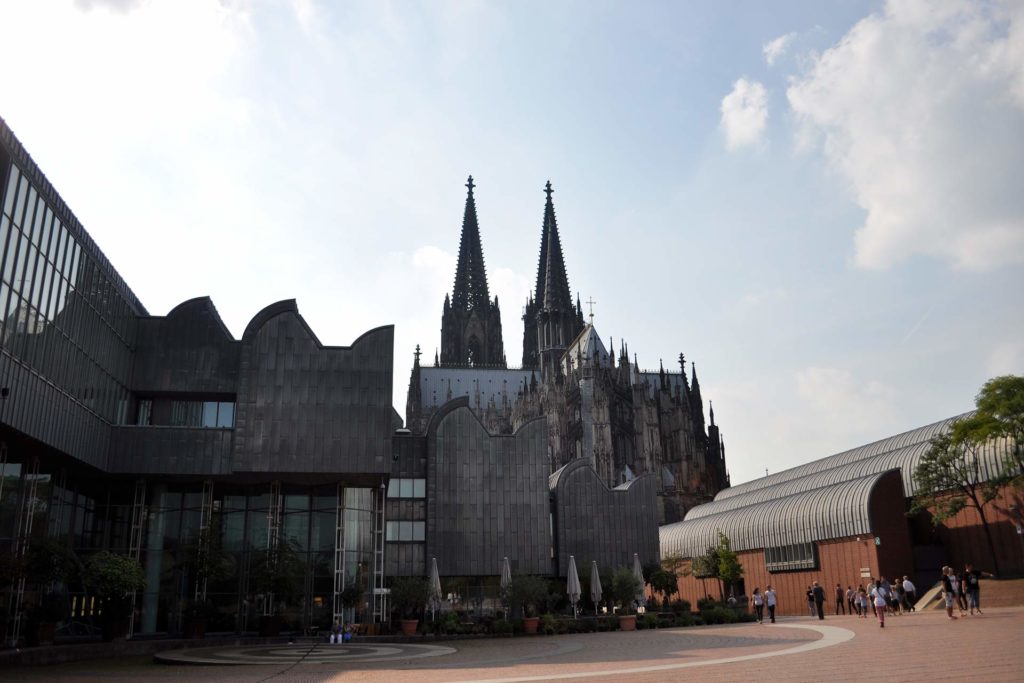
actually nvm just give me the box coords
[0,163,140,423]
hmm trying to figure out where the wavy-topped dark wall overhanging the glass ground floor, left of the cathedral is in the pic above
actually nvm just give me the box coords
[232,300,394,475]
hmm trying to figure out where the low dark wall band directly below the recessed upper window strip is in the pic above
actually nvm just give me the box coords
[108,426,233,476]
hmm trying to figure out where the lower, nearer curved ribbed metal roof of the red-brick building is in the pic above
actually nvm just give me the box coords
[659,470,895,557]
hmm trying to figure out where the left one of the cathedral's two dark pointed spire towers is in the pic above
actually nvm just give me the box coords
[440,176,506,368]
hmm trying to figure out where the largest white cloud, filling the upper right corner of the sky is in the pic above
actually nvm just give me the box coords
[786,0,1024,270]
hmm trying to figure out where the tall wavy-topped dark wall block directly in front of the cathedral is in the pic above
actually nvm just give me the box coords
[423,398,552,577]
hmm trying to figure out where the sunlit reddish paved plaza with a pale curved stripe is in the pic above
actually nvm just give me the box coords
[0,608,1024,683]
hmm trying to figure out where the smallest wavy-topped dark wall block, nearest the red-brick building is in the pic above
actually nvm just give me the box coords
[551,460,659,577]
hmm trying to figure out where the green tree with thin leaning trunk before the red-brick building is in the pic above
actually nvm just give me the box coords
[909,432,1004,574]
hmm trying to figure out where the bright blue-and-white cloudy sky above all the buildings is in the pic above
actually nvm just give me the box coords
[0,0,1024,483]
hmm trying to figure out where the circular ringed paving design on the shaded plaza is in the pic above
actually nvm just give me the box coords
[154,643,456,666]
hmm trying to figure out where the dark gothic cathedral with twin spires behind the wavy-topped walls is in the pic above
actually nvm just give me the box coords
[406,177,729,524]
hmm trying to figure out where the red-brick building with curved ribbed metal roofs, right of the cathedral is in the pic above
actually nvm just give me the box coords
[659,413,1024,615]
